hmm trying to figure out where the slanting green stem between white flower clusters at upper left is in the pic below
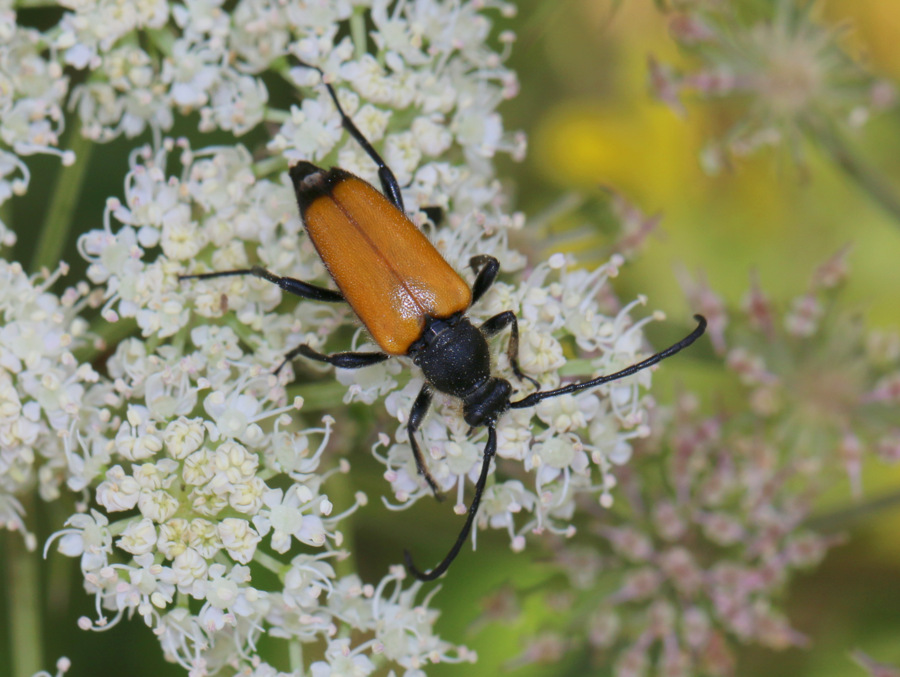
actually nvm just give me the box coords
[31,124,94,272]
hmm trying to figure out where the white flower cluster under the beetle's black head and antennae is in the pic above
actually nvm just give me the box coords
[372,252,650,550]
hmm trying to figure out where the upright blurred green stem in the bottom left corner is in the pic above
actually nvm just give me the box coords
[3,496,44,677]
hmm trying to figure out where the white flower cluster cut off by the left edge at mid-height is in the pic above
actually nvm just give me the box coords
[0,259,102,548]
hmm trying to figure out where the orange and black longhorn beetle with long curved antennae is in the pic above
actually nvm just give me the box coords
[180,66,706,580]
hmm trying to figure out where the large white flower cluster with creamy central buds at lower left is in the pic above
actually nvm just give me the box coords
[36,252,474,675]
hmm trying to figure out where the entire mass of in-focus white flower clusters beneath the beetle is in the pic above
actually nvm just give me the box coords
[0,0,672,677]
